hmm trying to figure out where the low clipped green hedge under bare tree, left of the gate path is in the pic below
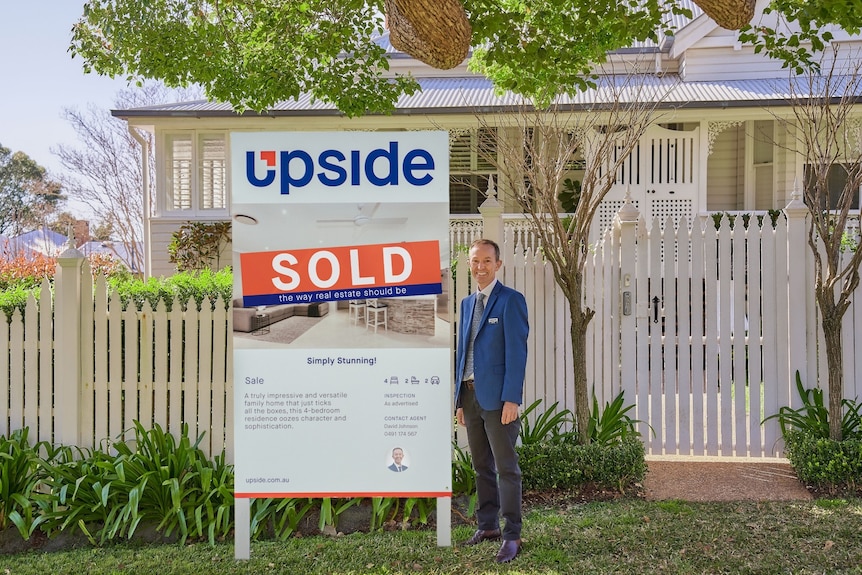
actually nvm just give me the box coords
[518,436,646,493]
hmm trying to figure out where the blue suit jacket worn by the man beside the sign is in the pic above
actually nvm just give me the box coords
[455,281,530,411]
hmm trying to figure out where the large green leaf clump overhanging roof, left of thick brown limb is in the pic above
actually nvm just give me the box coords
[71,0,417,115]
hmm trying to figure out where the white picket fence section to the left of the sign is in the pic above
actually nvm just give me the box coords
[0,260,233,460]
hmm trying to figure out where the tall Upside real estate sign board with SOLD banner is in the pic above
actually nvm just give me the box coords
[230,132,453,498]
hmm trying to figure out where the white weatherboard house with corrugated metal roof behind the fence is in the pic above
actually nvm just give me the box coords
[112,0,862,276]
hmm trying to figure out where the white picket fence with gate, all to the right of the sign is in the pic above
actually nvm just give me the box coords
[451,208,862,457]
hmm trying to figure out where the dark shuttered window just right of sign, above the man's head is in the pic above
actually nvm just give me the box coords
[449,128,497,214]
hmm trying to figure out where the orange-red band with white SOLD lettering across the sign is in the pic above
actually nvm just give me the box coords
[239,240,440,296]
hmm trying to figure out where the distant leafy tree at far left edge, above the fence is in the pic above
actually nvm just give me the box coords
[0,145,64,235]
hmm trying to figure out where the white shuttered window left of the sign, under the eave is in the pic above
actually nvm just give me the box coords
[159,132,228,217]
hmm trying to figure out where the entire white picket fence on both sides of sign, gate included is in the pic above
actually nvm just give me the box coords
[6,210,862,461]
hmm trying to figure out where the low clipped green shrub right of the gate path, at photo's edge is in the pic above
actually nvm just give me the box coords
[784,430,862,495]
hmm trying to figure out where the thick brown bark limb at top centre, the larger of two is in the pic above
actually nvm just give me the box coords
[384,0,473,70]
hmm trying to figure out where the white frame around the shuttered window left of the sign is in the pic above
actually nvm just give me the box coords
[156,130,230,219]
